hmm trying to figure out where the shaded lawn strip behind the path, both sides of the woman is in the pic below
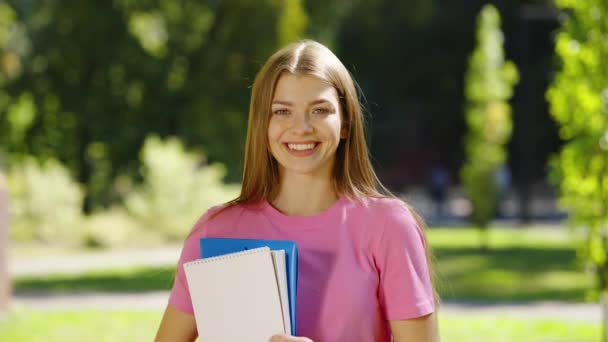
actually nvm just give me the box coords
[13,228,595,302]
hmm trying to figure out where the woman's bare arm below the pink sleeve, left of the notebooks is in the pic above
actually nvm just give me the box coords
[154,305,198,342]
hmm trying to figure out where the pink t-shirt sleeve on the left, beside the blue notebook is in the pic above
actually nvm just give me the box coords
[169,210,212,315]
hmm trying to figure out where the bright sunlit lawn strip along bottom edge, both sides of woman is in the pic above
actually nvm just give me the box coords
[0,311,600,342]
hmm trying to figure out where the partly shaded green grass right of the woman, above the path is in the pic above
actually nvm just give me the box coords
[428,228,595,302]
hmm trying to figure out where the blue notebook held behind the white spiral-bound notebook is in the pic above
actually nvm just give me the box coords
[200,238,298,335]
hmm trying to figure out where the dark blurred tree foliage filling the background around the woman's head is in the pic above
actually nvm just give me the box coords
[0,0,560,215]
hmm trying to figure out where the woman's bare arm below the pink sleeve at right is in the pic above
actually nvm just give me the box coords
[389,313,439,342]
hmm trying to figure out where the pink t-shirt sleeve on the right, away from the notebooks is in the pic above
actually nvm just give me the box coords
[375,204,435,320]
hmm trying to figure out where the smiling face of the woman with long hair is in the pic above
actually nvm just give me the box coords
[268,73,344,178]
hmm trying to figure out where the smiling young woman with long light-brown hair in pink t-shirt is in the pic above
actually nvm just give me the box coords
[156,40,438,342]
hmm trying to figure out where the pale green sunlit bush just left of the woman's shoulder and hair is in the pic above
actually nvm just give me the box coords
[124,136,239,241]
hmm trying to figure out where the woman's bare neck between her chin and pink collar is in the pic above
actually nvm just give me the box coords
[271,176,338,216]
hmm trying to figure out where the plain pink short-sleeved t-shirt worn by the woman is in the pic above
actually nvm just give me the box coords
[169,197,434,342]
